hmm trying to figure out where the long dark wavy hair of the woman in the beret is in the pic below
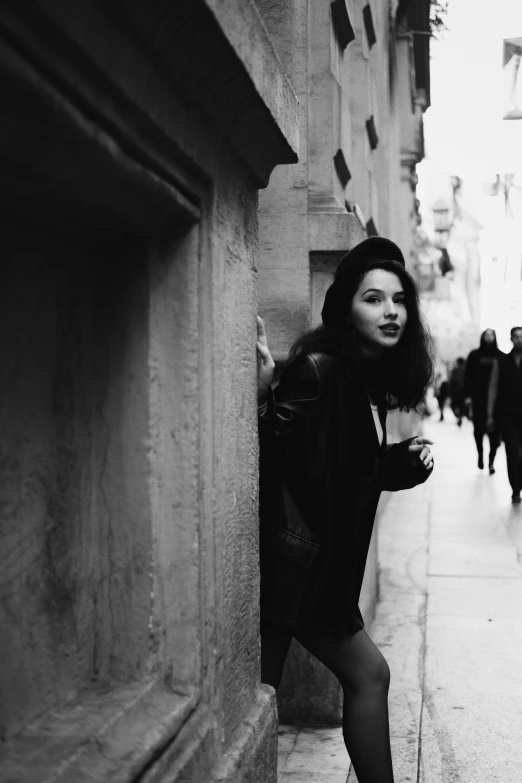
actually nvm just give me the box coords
[288,259,433,411]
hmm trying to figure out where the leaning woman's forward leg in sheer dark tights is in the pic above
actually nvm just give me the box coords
[296,630,393,783]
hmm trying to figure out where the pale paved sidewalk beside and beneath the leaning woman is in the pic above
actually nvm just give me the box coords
[279,413,522,783]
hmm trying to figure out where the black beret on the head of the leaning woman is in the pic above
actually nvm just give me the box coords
[321,237,406,328]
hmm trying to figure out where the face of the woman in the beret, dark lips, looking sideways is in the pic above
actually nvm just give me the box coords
[350,269,408,358]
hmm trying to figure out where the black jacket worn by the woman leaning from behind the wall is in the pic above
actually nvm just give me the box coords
[260,353,430,632]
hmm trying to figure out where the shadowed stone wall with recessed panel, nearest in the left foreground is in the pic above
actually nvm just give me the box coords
[0,0,298,783]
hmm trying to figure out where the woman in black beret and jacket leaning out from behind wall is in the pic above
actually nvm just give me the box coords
[257,237,433,783]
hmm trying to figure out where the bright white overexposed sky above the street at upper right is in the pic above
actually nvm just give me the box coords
[417,0,522,350]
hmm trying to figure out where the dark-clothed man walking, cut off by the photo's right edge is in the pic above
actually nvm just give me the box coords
[488,326,522,503]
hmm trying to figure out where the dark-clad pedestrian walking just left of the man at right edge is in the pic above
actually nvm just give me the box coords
[464,329,504,475]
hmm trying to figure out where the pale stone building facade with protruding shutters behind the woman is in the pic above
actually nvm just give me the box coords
[254,0,430,723]
